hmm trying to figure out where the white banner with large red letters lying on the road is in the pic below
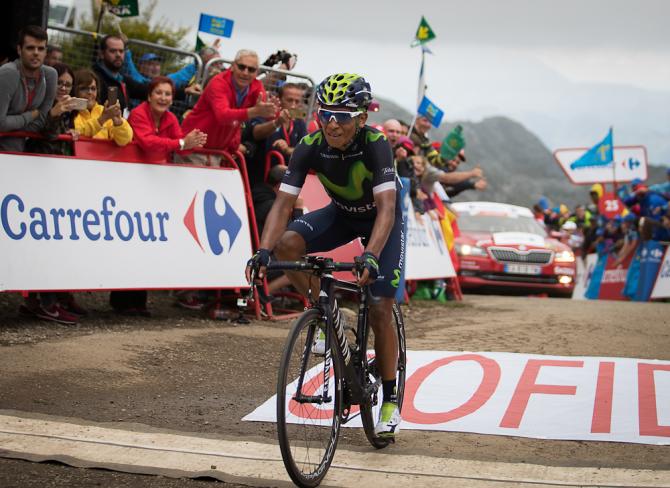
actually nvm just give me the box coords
[243,351,670,445]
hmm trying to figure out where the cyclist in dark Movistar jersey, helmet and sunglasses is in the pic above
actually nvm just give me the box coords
[246,73,404,438]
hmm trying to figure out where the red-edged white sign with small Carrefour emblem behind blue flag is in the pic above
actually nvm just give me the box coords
[554,146,647,185]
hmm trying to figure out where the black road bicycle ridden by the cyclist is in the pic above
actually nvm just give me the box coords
[255,256,406,487]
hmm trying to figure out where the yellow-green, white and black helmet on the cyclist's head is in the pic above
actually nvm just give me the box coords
[316,73,372,112]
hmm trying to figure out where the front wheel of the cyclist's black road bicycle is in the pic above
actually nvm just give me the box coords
[277,309,342,487]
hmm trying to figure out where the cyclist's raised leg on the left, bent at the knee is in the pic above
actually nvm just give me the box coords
[274,203,358,298]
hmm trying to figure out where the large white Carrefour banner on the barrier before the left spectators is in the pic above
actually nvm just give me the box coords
[0,154,251,291]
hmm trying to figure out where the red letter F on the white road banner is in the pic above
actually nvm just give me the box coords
[500,359,584,429]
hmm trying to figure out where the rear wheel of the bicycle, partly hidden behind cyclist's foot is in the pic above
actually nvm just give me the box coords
[360,302,407,449]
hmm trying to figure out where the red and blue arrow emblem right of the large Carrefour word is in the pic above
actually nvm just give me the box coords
[184,190,242,256]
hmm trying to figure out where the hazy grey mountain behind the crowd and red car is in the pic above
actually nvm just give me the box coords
[369,98,666,207]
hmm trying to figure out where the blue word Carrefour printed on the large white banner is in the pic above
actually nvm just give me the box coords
[0,193,170,242]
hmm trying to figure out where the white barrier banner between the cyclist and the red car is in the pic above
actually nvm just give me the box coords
[405,202,456,280]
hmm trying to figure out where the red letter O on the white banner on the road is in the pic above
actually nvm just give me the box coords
[402,354,500,425]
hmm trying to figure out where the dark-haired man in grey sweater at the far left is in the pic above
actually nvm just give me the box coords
[0,25,58,152]
